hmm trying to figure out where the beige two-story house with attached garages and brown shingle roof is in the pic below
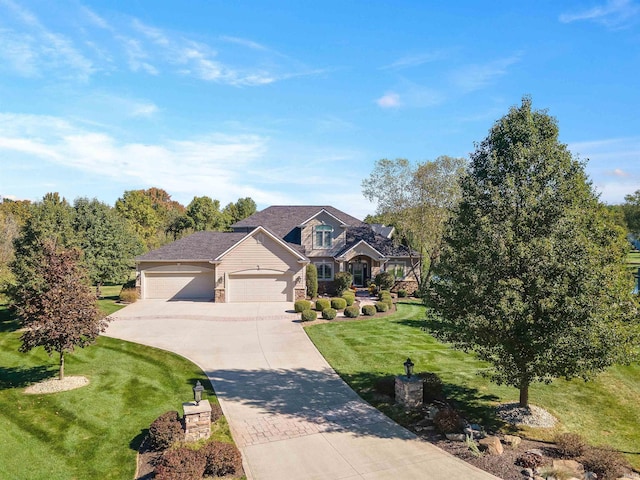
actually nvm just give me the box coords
[136,206,417,302]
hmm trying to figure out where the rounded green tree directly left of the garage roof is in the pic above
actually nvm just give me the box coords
[73,198,143,293]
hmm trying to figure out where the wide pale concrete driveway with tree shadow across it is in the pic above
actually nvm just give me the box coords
[106,300,497,480]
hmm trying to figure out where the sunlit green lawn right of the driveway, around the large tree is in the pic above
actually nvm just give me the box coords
[306,304,640,468]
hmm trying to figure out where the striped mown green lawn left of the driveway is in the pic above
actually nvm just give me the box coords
[0,305,222,480]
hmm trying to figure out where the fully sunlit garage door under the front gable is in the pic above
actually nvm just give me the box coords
[228,275,293,302]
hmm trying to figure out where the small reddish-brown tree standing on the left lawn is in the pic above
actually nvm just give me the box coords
[12,240,107,380]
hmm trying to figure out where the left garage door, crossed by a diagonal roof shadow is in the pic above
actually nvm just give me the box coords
[144,272,214,300]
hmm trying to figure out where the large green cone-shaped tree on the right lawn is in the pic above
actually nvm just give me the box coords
[430,97,637,406]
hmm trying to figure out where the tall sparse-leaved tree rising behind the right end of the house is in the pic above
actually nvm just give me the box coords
[362,156,465,291]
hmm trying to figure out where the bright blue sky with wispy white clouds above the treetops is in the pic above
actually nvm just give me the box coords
[0,0,640,218]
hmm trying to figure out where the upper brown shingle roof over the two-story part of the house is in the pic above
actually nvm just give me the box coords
[231,205,364,238]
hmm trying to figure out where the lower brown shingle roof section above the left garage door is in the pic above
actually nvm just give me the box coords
[136,232,247,262]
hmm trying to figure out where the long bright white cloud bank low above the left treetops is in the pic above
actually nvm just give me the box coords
[0,114,268,197]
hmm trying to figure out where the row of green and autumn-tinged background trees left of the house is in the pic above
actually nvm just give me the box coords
[0,187,256,288]
